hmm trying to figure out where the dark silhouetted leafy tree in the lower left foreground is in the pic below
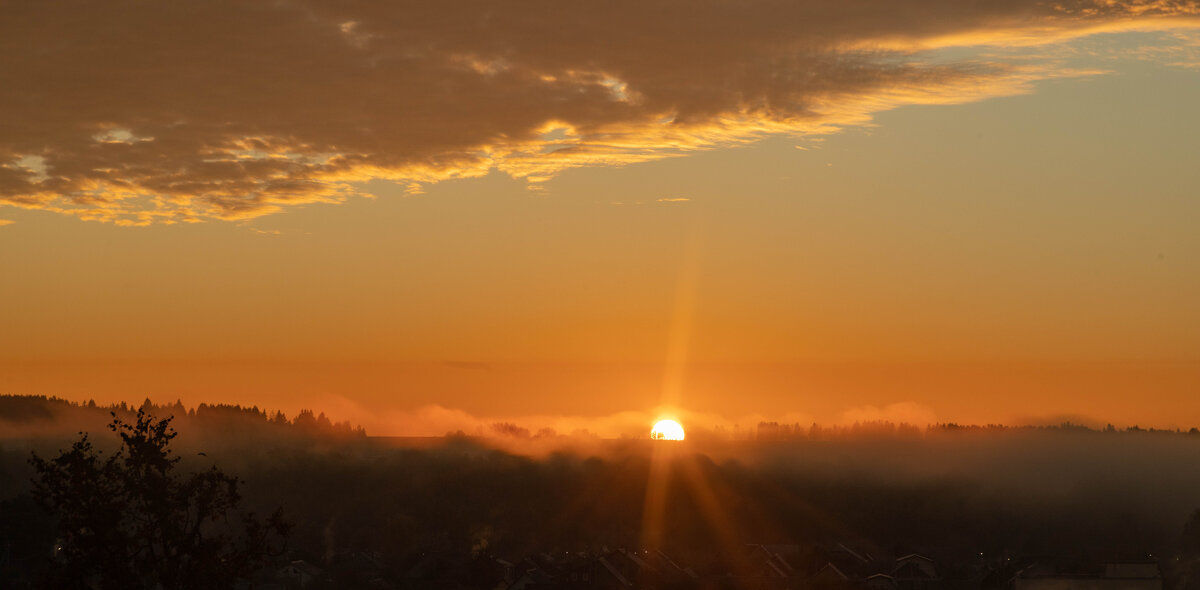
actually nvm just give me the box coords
[30,411,290,590]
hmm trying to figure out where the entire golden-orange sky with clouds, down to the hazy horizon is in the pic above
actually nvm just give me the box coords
[0,0,1200,434]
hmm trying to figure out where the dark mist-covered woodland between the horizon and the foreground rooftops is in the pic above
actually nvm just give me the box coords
[7,397,1200,575]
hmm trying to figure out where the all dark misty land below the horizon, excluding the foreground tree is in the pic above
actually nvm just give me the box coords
[0,397,1200,590]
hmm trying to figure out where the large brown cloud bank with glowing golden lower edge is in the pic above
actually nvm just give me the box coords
[0,0,1200,225]
